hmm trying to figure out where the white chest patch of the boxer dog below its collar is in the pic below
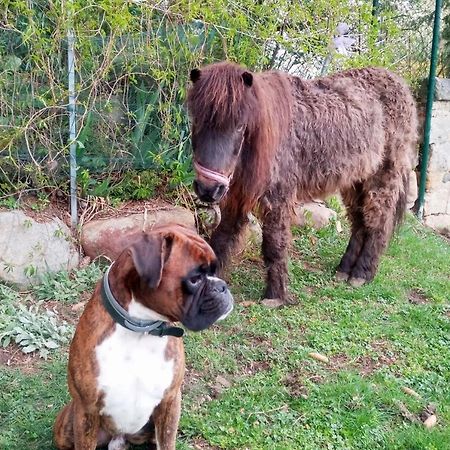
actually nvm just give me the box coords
[96,325,174,433]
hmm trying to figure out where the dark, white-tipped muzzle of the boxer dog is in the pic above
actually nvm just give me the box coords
[181,276,234,331]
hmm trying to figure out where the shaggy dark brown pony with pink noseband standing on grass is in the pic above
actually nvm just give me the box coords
[187,62,417,302]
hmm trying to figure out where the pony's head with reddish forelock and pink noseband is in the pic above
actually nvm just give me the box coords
[187,62,255,203]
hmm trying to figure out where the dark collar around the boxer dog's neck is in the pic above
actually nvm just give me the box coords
[101,263,184,337]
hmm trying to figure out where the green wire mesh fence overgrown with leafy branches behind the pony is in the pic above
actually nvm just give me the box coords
[0,0,440,206]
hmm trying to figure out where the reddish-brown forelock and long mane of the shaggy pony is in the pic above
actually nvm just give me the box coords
[187,61,292,211]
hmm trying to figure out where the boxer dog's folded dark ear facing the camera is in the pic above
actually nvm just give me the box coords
[130,234,173,289]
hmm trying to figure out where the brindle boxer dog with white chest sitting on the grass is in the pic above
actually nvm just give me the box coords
[53,225,233,450]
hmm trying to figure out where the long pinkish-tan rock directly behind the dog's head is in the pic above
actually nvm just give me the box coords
[81,207,195,261]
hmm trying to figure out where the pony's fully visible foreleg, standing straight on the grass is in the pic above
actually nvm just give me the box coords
[262,204,291,303]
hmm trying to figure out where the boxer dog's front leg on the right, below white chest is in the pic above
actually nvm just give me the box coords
[150,390,181,450]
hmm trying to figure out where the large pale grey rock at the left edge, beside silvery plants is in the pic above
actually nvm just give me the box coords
[0,210,79,288]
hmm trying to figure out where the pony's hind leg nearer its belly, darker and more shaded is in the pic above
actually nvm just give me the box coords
[336,183,365,281]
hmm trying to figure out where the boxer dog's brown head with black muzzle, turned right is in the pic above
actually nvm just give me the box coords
[111,225,233,331]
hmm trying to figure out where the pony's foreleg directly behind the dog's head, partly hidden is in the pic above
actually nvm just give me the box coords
[210,206,248,272]
